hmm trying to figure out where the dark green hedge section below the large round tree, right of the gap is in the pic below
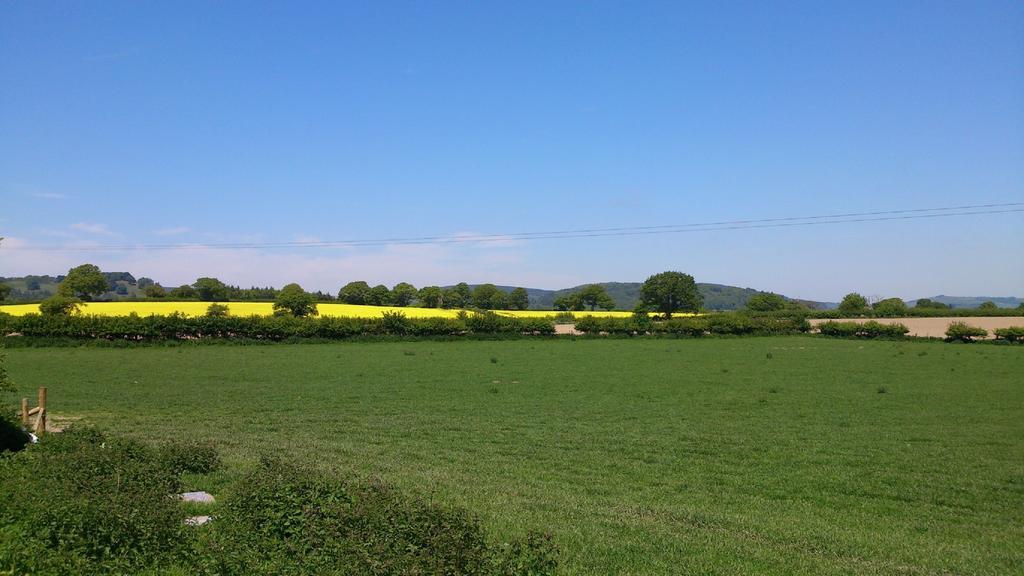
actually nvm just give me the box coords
[575,314,811,337]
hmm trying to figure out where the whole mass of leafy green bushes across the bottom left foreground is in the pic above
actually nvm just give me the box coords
[0,427,556,576]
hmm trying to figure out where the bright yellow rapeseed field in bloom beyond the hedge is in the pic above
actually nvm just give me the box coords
[0,301,632,318]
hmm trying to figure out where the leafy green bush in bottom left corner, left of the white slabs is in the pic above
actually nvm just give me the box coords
[0,428,185,574]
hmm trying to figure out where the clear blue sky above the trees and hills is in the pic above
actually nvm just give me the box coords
[0,2,1024,300]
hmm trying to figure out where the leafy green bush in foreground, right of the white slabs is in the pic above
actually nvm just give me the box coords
[193,458,555,575]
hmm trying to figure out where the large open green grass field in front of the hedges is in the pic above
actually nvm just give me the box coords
[7,337,1024,574]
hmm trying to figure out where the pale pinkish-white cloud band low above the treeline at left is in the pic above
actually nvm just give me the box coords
[0,239,582,292]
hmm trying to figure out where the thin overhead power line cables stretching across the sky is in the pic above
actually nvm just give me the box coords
[8,202,1024,252]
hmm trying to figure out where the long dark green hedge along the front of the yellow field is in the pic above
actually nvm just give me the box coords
[0,313,555,341]
